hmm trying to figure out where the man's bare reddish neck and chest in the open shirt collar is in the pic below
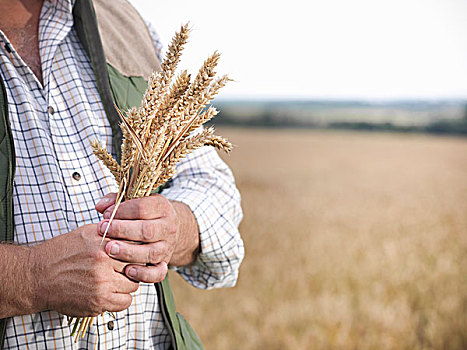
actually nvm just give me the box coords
[0,0,43,83]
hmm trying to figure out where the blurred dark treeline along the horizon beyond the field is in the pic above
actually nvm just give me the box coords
[214,102,467,136]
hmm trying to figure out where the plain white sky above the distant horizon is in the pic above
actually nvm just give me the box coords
[131,0,467,99]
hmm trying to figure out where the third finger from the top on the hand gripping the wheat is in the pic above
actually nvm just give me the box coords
[105,241,172,264]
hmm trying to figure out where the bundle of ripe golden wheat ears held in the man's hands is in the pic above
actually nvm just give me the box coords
[69,25,232,341]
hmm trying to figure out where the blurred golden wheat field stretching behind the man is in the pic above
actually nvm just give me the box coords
[171,128,467,350]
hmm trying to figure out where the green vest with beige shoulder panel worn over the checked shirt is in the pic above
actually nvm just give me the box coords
[0,0,204,350]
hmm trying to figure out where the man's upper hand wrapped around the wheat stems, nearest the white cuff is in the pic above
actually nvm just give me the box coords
[96,193,199,283]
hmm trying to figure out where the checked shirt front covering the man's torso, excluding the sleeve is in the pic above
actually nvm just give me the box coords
[0,1,170,349]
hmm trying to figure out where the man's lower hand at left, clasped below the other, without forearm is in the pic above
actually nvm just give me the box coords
[29,224,139,317]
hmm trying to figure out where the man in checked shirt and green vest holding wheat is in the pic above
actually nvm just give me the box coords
[0,0,247,349]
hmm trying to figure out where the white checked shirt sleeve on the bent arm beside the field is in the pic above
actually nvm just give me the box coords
[162,147,244,289]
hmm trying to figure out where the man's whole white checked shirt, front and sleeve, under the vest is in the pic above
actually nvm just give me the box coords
[0,0,244,349]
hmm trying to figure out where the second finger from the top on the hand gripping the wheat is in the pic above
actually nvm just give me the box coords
[98,219,177,243]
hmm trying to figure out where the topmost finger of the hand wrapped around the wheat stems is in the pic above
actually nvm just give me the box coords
[104,194,173,220]
